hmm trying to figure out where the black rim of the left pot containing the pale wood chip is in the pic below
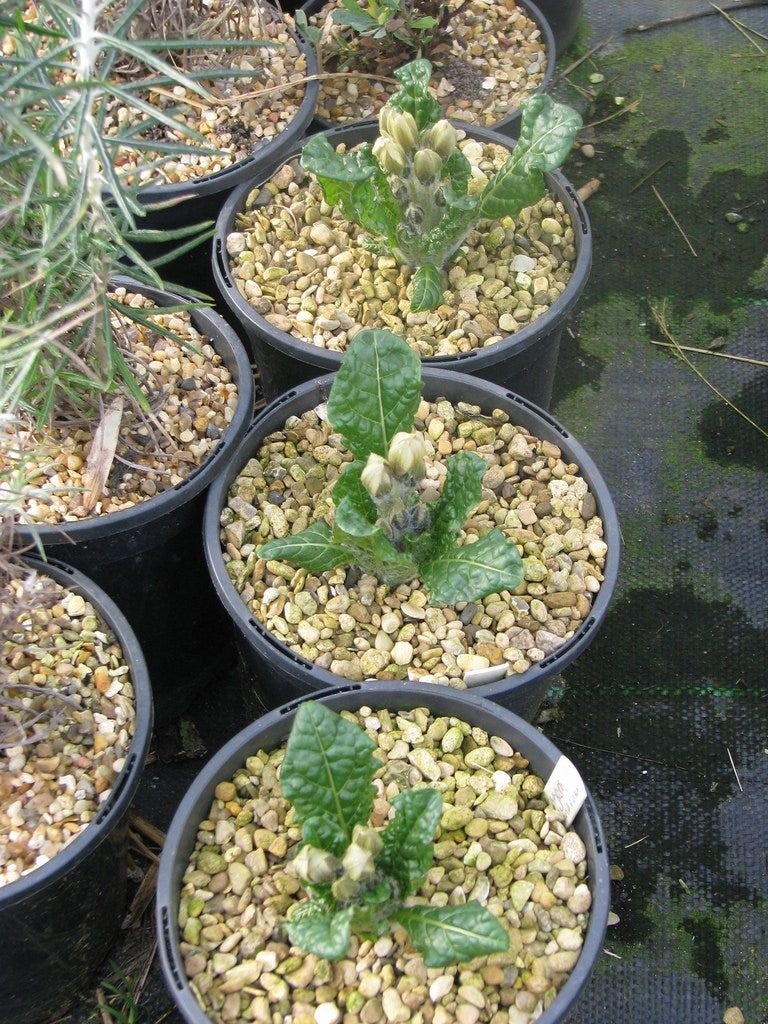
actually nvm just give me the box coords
[17,275,255,547]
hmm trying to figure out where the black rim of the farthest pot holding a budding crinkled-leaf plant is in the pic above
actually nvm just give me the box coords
[212,120,592,373]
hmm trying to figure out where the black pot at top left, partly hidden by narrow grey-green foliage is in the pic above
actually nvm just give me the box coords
[132,17,319,234]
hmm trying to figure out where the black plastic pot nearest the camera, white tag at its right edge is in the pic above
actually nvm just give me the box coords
[156,683,610,1024]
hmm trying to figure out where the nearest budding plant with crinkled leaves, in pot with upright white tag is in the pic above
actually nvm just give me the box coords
[280,700,509,967]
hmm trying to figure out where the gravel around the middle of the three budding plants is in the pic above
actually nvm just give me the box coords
[221,399,607,688]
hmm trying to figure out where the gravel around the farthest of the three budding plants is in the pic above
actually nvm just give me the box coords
[227,139,577,356]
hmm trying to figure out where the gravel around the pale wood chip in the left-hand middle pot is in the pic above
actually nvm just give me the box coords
[6,288,238,523]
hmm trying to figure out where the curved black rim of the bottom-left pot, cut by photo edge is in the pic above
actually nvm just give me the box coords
[0,558,154,910]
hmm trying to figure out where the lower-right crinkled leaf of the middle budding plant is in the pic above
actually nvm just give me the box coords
[420,529,522,604]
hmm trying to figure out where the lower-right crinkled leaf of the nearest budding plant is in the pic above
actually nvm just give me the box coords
[394,900,509,967]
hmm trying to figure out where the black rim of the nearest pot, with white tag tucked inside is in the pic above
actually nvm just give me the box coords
[156,681,610,1024]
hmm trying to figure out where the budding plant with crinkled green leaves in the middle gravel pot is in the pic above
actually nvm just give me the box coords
[259,331,522,604]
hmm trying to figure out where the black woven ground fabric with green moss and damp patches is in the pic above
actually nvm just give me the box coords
[55,0,768,1024]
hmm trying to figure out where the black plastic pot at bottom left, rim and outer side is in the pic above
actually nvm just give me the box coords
[0,559,153,1024]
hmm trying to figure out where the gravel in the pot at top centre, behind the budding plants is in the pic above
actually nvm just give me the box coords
[309,0,547,128]
